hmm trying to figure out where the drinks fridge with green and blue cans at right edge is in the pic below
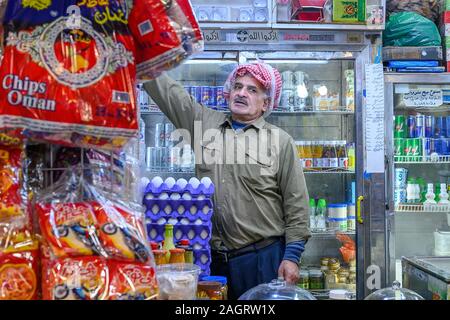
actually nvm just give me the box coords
[385,74,450,287]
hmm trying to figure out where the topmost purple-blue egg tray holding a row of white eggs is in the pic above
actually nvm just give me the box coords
[145,177,214,196]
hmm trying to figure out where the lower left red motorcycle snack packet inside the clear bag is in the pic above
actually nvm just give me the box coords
[42,257,109,300]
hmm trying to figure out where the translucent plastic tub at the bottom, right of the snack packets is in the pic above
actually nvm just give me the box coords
[156,263,200,300]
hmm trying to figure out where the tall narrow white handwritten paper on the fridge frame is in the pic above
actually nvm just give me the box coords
[365,63,385,173]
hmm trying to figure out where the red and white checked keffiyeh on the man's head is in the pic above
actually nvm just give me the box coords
[224,61,282,117]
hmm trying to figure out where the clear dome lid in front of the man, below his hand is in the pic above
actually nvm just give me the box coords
[239,278,317,300]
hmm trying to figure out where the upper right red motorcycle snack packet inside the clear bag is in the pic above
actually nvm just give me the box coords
[96,203,151,263]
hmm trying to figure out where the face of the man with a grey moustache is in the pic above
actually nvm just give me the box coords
[229,74,269,122]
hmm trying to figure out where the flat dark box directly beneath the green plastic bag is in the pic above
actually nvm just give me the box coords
[383,46,444,61]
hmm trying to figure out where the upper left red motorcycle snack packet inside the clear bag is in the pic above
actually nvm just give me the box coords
[36,202,102,258]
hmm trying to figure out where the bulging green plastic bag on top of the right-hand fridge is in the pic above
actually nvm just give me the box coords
[383,12,442,47]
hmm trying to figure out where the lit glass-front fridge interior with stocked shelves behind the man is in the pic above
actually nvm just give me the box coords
[140,46,372,293]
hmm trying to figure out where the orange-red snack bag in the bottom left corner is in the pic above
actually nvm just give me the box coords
[0,241,39,300]
